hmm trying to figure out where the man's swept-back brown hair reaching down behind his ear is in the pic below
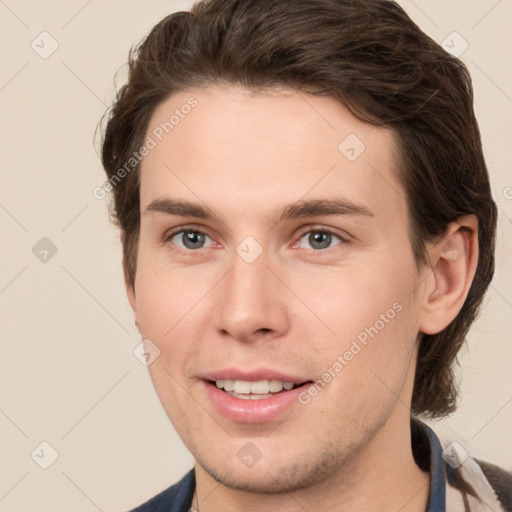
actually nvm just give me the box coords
[102,0,497,417]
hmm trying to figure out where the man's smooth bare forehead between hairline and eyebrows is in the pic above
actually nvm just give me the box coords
[141,86,403,222]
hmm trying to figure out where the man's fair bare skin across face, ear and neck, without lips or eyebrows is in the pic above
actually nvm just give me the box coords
[127,86,478,512]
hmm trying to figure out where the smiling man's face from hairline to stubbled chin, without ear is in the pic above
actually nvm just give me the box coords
[128,87,428,492]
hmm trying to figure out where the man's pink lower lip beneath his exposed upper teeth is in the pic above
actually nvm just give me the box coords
[203,381,308,423]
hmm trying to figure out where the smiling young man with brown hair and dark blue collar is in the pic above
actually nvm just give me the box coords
[98,0,512,512]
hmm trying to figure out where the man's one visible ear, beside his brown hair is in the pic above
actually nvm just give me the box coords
[419,214,478,334]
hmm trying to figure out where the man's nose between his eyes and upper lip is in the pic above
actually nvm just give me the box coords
[215,246,290,342]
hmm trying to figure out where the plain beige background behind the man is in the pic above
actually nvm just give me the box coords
[0,0,512,512]
